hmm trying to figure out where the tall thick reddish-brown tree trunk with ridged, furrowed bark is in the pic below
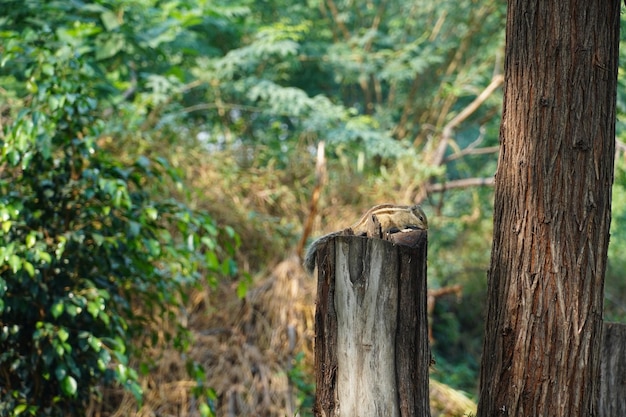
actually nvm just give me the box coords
[478,0,620,417]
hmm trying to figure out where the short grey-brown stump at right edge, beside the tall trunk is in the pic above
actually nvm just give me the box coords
[598,323,626,417]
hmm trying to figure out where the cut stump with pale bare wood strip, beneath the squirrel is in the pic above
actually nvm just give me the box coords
[314,230,430,417]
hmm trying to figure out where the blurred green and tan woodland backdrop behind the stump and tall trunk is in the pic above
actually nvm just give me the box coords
[0,0,626,416]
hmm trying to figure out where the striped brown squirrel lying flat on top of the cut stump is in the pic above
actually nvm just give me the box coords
[304,204,428,274]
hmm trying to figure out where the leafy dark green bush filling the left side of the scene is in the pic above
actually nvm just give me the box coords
[0,1,236,416]
